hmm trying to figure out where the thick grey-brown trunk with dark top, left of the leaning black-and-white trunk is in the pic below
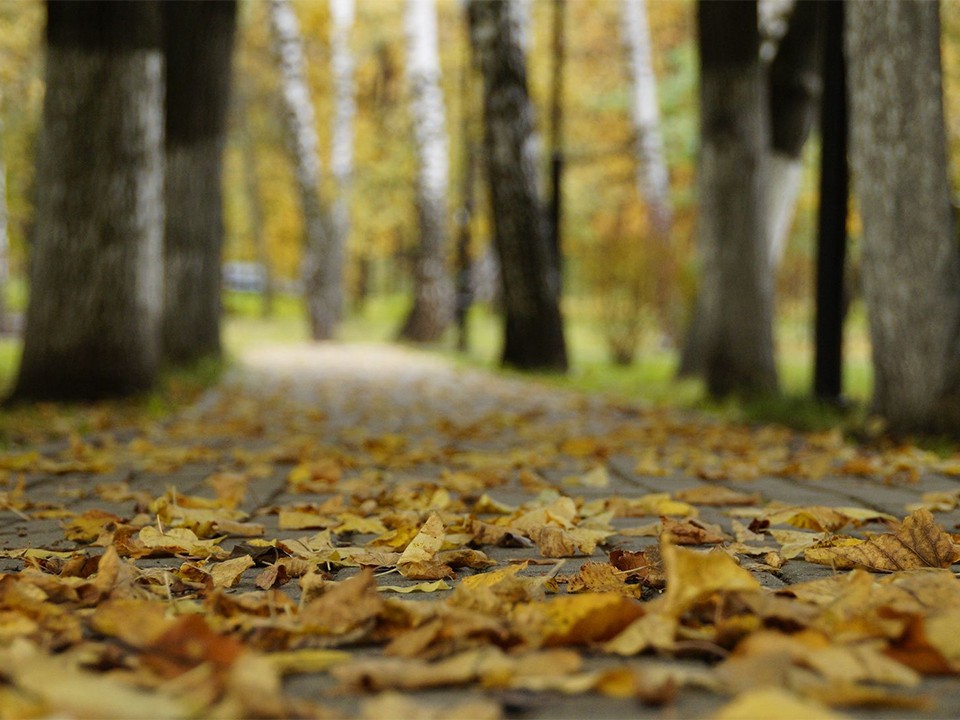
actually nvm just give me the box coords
[697,0,777,397]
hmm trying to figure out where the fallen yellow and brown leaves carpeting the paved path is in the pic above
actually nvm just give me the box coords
[0,351,960,718]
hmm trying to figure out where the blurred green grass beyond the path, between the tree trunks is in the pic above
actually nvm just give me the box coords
[0,292,872,441]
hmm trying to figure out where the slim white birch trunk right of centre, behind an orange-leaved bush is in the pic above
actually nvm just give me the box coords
[621,0,673,242]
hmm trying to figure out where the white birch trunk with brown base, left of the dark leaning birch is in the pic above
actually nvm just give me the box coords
[400,0,454,342]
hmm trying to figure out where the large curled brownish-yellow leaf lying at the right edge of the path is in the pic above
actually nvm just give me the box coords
[804,508,960,572]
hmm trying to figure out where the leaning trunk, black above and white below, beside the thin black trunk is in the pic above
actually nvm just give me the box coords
[764,2,826,274]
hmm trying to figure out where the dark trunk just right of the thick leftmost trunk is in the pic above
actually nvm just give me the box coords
[161,0,237,365]
